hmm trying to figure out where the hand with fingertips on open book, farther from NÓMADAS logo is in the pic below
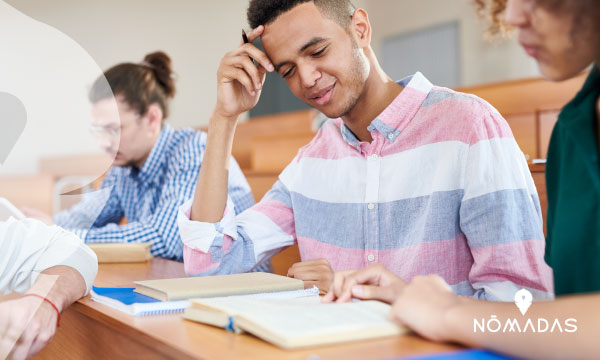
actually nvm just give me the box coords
[323,264,406,304]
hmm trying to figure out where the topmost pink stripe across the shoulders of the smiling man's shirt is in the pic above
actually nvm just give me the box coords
[298,88,513,160]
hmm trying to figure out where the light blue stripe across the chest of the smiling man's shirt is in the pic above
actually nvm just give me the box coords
[291,190,463,250]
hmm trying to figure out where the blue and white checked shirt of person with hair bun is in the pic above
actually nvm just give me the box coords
[54,124,254,261]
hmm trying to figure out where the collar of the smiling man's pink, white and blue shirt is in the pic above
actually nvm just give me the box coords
[340,71,433,152]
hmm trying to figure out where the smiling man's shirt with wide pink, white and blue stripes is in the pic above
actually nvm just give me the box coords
[179,73,553,301]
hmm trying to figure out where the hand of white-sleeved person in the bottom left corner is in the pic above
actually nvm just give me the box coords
[0,297,57,359]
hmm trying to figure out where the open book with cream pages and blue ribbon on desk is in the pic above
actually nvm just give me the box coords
[183,296,407,349]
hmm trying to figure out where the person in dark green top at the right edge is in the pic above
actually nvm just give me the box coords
[324,0,600,359]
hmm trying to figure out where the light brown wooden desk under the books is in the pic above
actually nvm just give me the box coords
[35,259,458,360]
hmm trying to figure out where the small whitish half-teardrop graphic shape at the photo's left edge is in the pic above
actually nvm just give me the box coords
[0,91,27,165]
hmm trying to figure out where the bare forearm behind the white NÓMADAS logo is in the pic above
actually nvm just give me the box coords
[444,295,600,359]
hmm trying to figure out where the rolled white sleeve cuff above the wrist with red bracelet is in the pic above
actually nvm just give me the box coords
[31,227,98,295]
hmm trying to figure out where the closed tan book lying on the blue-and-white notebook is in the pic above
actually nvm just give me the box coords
[134,272,304,301]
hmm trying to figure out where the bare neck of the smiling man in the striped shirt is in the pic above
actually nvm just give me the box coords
[342,59,403,142]
